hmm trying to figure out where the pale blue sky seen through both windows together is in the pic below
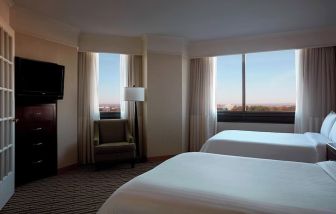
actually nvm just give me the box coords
[99,50,296,105]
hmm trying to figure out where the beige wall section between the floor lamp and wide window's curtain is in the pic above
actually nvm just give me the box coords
[143,35,189,157]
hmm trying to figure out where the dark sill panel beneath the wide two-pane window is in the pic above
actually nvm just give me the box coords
[217,111,295,124]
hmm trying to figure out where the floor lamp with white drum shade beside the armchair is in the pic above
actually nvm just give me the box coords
[124,87,145,159]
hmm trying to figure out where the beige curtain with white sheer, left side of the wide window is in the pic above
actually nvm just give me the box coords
[189,57,217,151]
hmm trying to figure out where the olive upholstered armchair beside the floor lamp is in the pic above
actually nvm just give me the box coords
[94,119,135,168]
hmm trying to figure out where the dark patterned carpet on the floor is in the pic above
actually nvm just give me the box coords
[0,162,159,214]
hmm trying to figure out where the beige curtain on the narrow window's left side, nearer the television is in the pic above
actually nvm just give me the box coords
[77,52,99,164]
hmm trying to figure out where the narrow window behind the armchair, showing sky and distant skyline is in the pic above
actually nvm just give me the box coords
[99,53,120,119]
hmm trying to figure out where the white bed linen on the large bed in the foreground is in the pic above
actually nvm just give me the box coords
[98,152,336,214]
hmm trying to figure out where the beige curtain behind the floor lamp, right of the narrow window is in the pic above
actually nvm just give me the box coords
[121,55,147,160]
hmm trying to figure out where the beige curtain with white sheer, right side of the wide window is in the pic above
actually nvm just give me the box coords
[294,47,336,133]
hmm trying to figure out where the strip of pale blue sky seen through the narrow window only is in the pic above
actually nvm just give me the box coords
[99,53,120,104]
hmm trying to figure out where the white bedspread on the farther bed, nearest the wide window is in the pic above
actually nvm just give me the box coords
[201,130,330,163]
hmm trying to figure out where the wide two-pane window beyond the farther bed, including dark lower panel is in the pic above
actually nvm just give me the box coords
[216,50,296,123]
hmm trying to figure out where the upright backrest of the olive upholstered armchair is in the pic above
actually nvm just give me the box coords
[99,120,127,144]
